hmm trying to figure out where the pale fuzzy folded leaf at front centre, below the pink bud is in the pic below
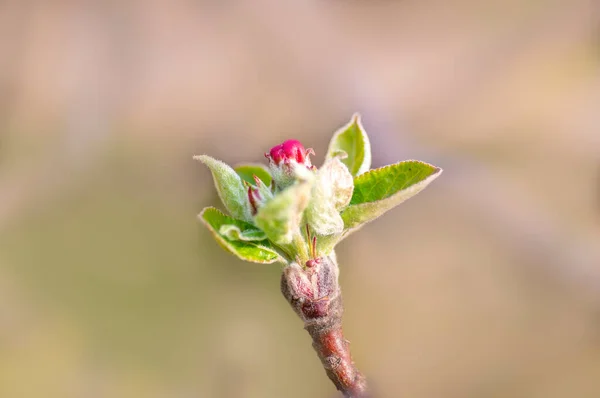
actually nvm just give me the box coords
[254,180,313,245]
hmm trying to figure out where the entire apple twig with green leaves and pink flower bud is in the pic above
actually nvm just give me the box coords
[195,115,442,397]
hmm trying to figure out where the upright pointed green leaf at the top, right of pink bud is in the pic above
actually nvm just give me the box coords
[326,113,371,176]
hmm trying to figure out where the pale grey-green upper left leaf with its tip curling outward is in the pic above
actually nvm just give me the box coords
[194,155,252,221]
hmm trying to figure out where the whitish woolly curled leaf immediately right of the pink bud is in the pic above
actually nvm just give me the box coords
[306,158,354,235]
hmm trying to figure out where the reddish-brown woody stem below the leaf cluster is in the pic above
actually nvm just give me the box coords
[281,253,369,398]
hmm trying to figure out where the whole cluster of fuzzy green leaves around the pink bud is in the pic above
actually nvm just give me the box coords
[195,115,442,263]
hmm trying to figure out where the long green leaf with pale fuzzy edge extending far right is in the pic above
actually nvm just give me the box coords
[342,160,442,232]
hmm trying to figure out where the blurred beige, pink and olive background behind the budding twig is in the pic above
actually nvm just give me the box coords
[0,0,600,398]
